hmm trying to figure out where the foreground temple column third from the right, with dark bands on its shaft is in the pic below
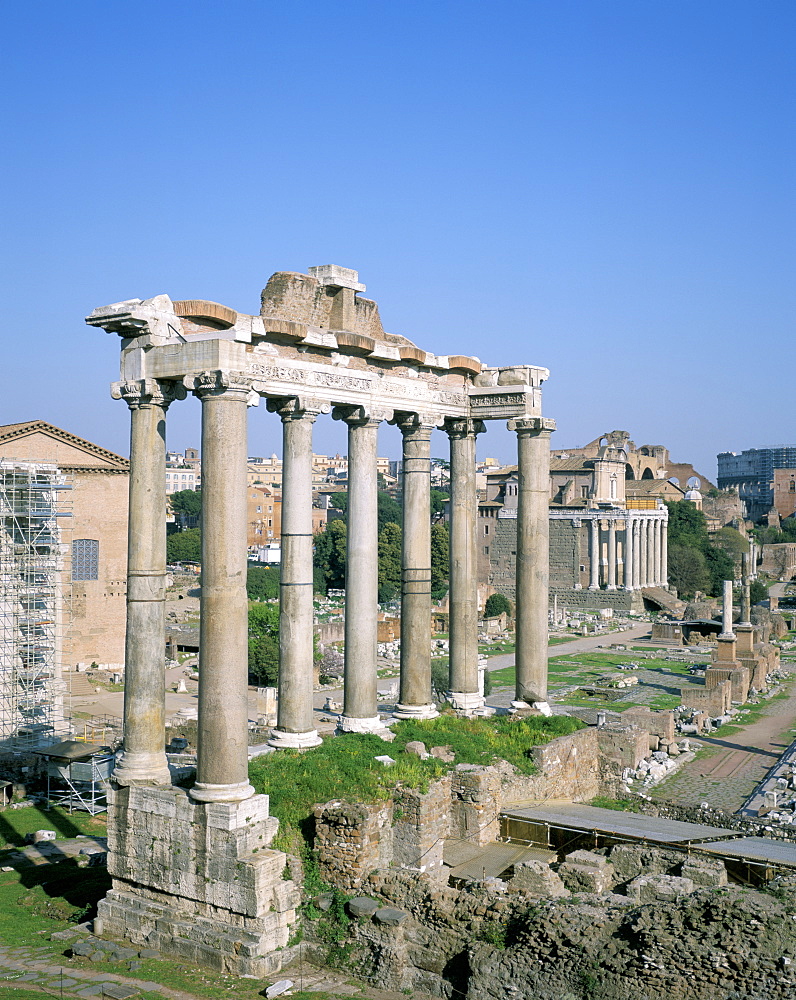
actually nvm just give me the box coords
[394,413,439,719]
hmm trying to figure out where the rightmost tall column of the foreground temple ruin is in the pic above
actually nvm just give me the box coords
[509,417,556,712]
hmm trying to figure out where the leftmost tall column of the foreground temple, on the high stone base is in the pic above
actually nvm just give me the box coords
[112,379,186,785]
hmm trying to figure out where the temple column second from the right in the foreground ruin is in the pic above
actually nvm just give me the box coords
[445,419,484,715]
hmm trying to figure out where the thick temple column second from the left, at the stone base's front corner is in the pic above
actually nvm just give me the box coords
[191,371,254,802]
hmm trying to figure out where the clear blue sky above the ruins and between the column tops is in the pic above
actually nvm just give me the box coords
[0,0,796,477]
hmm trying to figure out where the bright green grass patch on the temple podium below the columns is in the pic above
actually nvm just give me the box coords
[249,715,581,827]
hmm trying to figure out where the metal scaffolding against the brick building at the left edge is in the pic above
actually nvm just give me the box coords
[0,460,71,748]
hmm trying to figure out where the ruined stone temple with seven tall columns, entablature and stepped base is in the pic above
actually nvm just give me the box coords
[87,266,554,974]
